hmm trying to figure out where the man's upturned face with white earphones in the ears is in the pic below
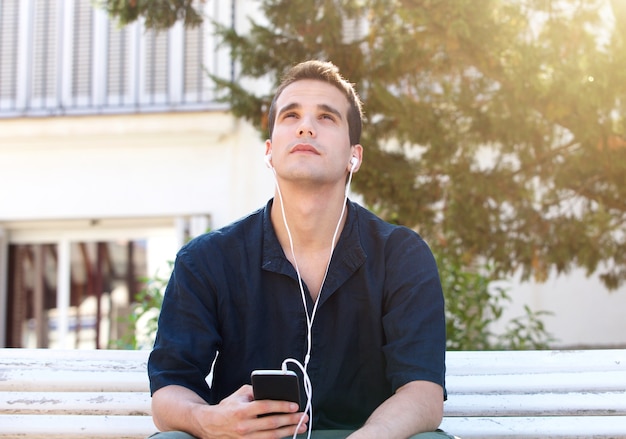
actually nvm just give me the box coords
[266,80,361,184]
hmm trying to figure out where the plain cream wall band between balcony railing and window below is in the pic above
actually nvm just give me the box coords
[0,113,273,226]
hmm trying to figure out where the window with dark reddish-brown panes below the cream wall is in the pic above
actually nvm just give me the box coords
[6,241,147,349]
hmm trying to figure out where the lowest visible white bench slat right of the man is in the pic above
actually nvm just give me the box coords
[441,416,626,439]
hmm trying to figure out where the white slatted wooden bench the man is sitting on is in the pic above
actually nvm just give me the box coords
[0,349,626,439]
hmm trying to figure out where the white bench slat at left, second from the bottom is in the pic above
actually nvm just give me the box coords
[0,392,152,416]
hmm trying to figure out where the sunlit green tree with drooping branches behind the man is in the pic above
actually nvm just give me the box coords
[103,0,626,288]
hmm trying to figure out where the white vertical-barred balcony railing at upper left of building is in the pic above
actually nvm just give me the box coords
[0,0,236,118]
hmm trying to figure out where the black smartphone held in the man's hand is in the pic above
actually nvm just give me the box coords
[251,370,300,412]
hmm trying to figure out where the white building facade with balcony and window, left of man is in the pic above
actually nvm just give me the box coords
[0,0,273,348]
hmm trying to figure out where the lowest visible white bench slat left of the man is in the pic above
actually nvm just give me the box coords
[0,415,158,439]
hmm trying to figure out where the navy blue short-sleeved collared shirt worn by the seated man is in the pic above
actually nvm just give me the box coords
[148,200,445,429]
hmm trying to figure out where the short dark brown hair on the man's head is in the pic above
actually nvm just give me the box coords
[267,60,363,145]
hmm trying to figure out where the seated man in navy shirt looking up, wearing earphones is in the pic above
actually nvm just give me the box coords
[148,61,449,439]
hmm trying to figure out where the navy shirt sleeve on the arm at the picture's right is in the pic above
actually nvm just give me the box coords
[383,227,446,396]
